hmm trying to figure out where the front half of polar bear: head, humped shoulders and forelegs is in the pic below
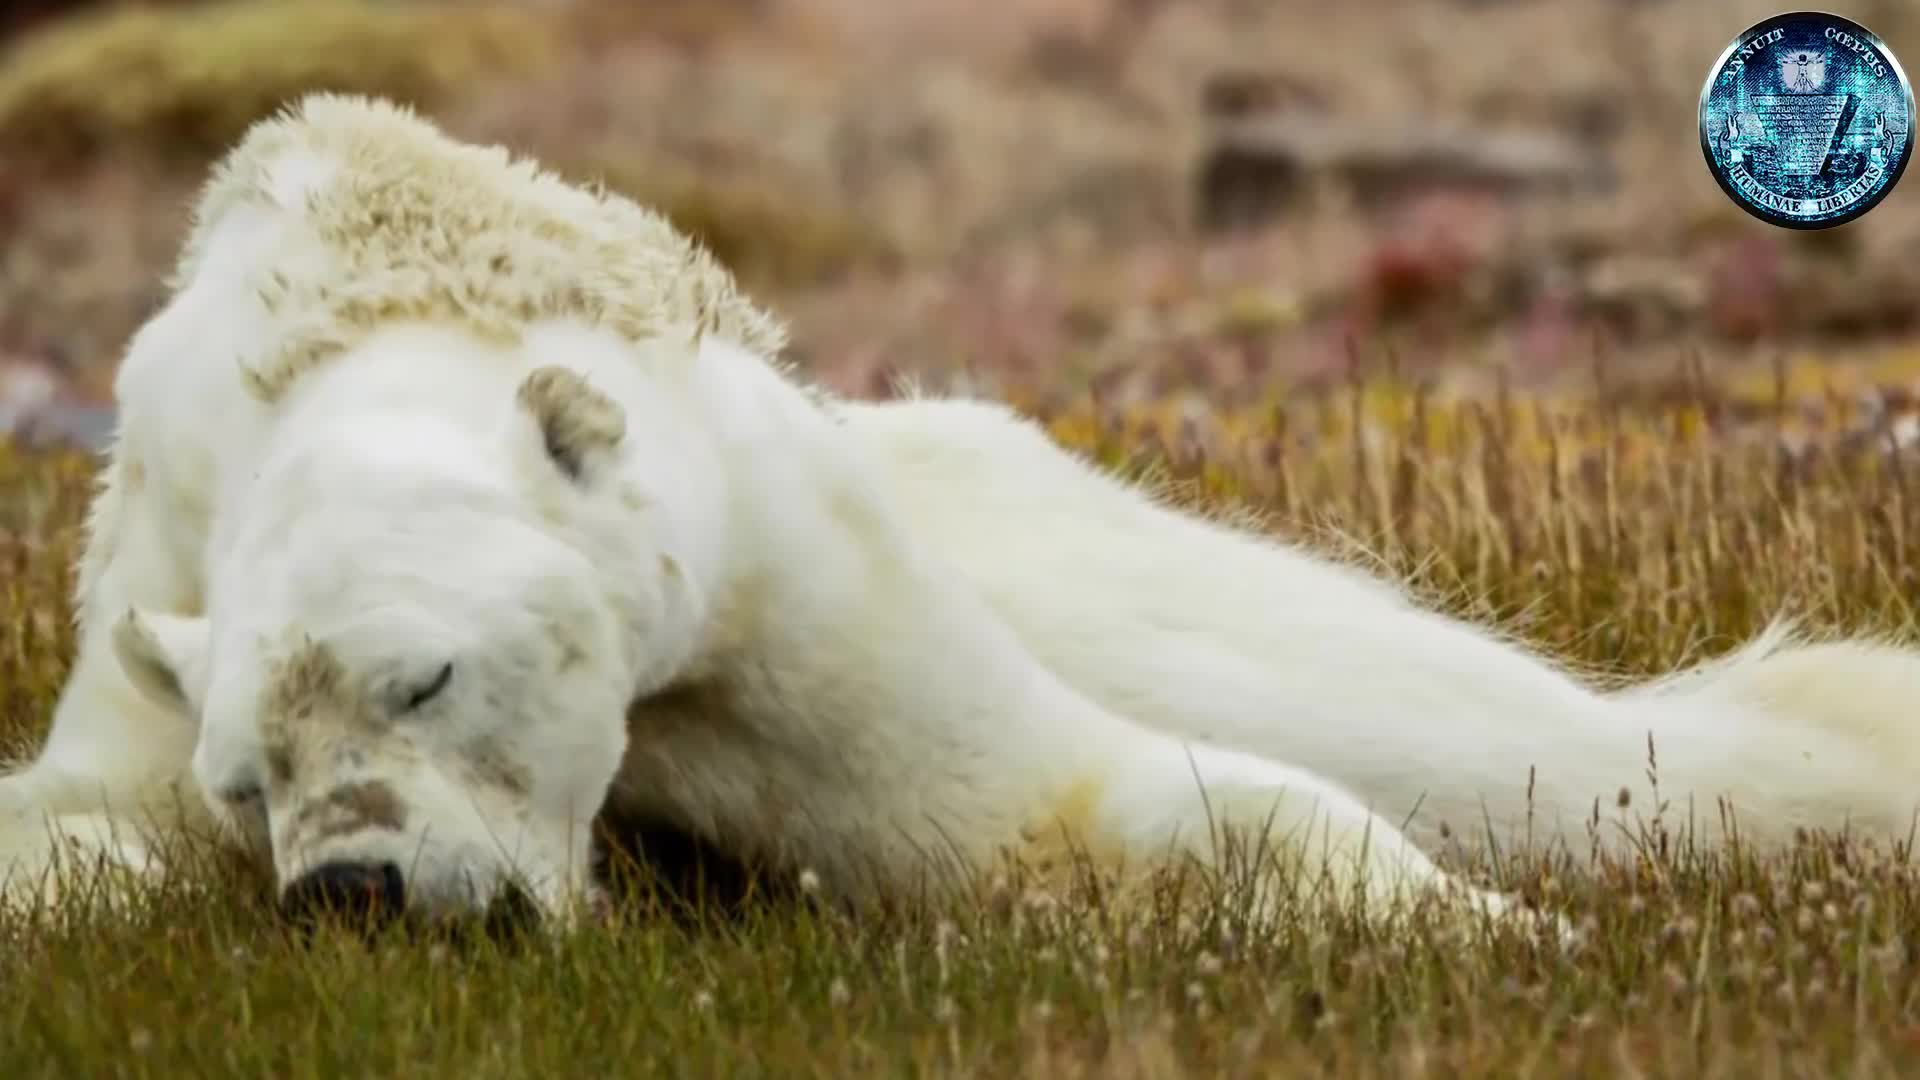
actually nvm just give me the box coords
[0,94,1513,924]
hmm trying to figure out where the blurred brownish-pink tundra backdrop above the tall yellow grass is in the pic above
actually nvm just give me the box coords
[0,0,1920,444]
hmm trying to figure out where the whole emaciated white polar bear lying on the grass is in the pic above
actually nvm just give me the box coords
[0,96,1920,930]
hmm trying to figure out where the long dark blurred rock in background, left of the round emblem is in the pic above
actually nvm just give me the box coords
[1196,111,1613,229]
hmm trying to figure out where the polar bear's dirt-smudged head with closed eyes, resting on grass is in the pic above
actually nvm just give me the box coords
[113,367,697,915]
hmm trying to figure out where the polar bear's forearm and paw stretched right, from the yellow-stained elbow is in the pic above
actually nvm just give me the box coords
[1083,732,1536,924]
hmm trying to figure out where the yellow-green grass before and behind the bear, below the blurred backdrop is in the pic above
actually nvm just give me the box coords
[0,367,1920,1076]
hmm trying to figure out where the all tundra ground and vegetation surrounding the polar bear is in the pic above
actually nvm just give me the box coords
[0,0,1920,1076]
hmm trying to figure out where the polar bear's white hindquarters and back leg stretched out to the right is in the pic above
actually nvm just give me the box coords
[845,400,1920,851]
